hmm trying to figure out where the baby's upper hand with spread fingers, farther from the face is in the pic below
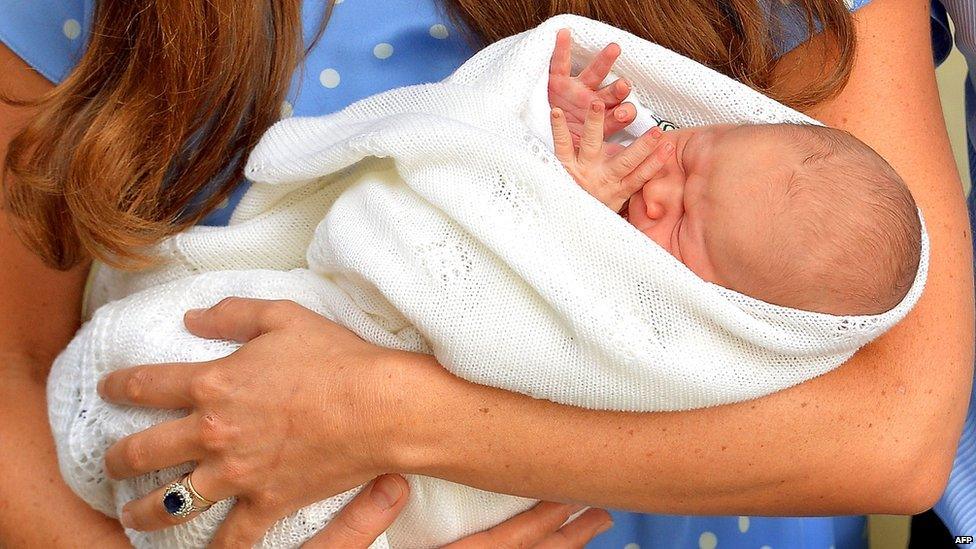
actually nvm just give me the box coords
[549,29,637,146]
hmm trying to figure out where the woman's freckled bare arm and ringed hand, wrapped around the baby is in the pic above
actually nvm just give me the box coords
[99,0,973,539]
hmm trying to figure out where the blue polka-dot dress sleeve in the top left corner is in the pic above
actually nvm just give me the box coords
[0,0,94,84]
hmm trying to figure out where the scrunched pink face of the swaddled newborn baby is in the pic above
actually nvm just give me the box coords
[627,125,802,294]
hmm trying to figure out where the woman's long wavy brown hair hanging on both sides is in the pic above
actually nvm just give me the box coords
[2,0,855,269]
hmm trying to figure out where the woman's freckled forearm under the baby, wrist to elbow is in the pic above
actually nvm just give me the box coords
[394,328,965,515]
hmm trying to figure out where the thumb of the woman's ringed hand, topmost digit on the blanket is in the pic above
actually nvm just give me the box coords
[183,297,308,343]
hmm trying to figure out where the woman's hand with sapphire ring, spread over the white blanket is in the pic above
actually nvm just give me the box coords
[99,298,397,546]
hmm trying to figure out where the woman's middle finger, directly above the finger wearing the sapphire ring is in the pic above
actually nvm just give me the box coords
[105,416,201,479]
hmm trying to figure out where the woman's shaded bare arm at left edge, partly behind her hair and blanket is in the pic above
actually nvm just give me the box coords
[0,45,127,547]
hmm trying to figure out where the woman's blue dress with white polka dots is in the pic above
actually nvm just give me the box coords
[0,0,867,549]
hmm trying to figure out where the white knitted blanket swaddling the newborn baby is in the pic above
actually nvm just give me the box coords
[49,12,928,547]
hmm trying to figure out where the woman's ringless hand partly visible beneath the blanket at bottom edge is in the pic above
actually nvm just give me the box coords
[304,475,613,549]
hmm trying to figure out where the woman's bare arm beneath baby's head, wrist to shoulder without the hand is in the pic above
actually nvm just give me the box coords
[386,0,973,515]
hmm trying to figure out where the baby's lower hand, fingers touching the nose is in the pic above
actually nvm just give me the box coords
[550,101,674,212]
